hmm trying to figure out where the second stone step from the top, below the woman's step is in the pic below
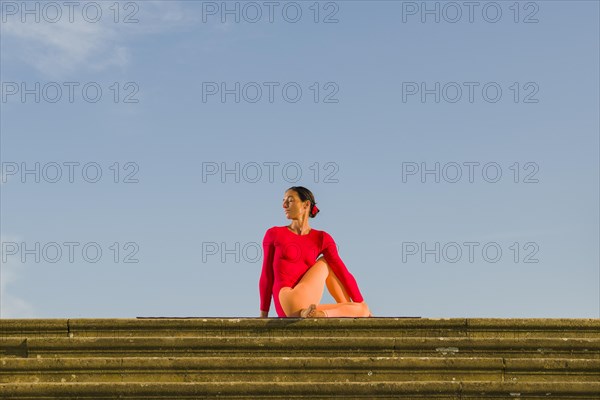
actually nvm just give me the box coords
[0,336,600,359]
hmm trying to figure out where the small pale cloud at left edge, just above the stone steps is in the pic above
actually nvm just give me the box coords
[0,235,36,318]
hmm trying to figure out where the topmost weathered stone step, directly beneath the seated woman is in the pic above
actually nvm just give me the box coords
[0,317,600,339]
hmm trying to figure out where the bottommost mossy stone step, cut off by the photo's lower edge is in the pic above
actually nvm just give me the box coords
[3,382,600,400]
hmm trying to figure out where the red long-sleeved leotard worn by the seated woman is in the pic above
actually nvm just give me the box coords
[258,226,363,317]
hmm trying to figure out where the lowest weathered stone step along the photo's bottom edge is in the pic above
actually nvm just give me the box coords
[0,381,600,400]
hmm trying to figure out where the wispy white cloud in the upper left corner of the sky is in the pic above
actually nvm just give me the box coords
[1,1,232,80]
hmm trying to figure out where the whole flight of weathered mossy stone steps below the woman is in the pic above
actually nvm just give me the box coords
[0,318,600,400]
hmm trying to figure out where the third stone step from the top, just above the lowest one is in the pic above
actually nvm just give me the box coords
[0,355,600,383]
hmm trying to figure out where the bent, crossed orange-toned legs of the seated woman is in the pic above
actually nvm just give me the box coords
[279,257,371,317]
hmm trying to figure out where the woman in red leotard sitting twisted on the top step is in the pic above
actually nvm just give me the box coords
[259,186,372,318]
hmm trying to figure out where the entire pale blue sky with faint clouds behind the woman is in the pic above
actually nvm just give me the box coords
[0,1,600,318]
